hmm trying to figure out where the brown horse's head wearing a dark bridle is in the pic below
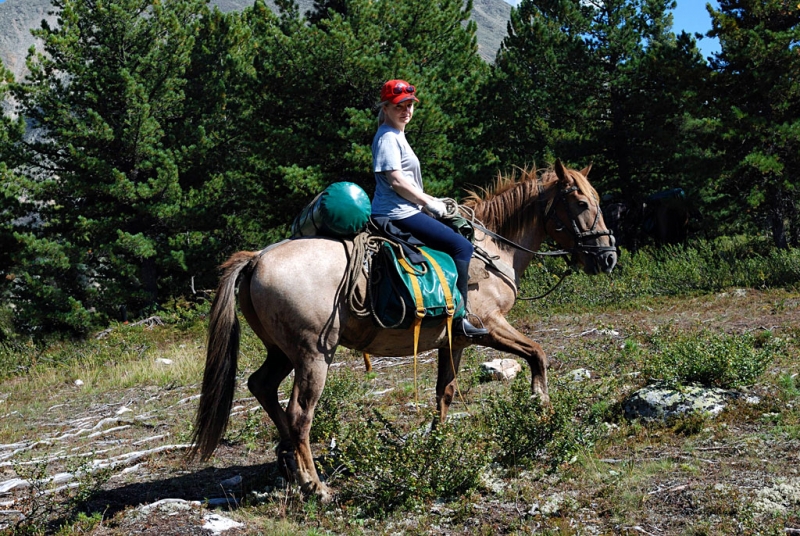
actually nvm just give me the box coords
[543,160,617,275]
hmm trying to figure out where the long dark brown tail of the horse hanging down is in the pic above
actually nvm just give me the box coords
[188,251,258,460]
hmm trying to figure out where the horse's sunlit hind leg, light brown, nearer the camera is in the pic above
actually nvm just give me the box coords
[286,357,332,502]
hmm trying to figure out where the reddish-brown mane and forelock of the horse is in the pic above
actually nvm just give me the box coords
[463,166,600,240]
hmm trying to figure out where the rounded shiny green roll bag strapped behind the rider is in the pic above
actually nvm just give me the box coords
[292,182,372,238]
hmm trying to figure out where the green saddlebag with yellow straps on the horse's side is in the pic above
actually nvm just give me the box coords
[370,244,466,329]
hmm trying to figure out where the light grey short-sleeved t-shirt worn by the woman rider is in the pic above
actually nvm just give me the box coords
[372,123,423,220]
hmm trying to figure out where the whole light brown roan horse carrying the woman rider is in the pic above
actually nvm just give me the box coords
[193,162,616,500]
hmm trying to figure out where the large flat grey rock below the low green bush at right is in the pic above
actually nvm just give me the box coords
[623,384,741,420]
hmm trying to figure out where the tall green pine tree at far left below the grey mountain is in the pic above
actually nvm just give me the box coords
[9,0,206,331]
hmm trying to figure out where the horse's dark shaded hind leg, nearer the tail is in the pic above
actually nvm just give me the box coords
[247,346,297,481]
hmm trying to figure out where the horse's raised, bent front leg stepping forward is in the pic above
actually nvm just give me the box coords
[481,313,550,406]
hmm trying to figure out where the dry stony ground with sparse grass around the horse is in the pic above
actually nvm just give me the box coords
[0,289,800,536]
